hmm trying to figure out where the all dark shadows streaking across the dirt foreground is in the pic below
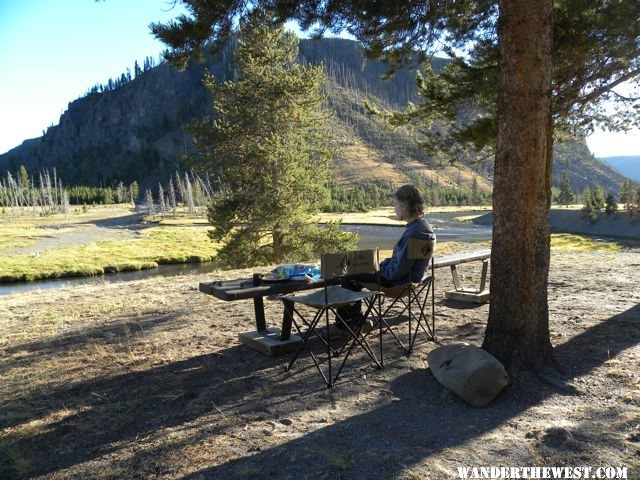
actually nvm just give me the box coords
[0,306,640,479]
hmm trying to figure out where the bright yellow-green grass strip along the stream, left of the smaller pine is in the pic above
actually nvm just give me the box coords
[0,226,216,282]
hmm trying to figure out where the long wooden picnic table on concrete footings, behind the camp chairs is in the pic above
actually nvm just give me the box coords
[199,249,491,355]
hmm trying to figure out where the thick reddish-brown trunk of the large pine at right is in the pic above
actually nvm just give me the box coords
[483,0,553,371]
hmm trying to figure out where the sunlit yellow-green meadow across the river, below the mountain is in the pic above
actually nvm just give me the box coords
[0,205,620,282]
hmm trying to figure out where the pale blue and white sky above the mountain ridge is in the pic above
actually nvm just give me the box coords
[0,0,640,157]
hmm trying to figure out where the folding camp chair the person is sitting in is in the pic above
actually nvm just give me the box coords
[367,238,435,358]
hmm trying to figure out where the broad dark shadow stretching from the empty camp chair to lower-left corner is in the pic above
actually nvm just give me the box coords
[0,320,380,478]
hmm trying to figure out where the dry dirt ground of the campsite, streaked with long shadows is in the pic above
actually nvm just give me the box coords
[0,249,640,479]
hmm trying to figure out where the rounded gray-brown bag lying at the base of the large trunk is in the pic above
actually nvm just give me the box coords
[427,343,509,407]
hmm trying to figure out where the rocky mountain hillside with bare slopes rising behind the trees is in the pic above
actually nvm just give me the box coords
[0,39,622,199]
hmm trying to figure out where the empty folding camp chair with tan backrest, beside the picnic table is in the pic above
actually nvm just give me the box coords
[281,249,382,387]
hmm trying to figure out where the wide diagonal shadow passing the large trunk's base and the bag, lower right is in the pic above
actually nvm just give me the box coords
[172,306,640,480]
